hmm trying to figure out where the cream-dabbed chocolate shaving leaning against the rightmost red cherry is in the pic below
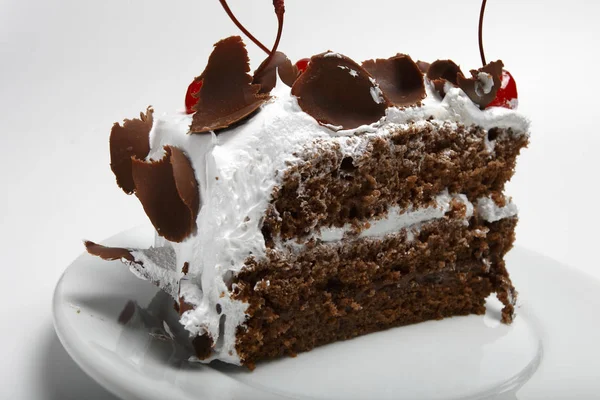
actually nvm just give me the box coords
[458,60,504,110]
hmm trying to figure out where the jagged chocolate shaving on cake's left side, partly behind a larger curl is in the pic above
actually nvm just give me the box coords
[110,107,154,194]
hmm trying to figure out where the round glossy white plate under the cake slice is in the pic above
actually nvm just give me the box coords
[53,227,600,400]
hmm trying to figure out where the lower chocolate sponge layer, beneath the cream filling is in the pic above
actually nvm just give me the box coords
[234,216,517,368]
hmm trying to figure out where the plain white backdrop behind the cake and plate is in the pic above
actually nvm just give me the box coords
[0,0,600,400]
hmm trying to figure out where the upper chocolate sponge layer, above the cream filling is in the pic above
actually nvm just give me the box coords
[262,122,528,247]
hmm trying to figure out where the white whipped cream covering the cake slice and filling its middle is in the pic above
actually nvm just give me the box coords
[136,78,529,364]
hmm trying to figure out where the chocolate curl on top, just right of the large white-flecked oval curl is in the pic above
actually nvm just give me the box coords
[362,54,426,107]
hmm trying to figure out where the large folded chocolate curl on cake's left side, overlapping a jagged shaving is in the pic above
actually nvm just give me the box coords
[132,146,200,242]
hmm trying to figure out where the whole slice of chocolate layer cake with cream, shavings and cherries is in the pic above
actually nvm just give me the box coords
[86,1,529,368]
